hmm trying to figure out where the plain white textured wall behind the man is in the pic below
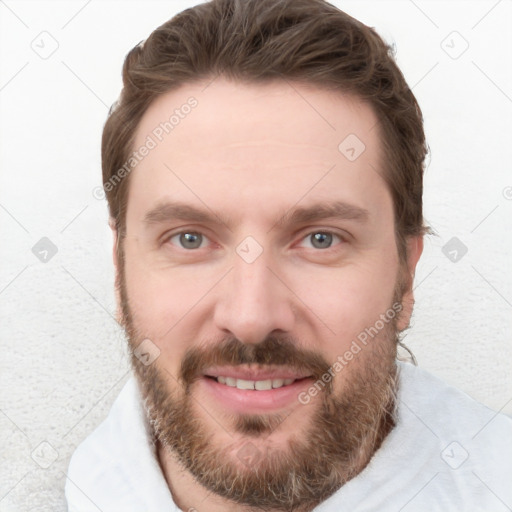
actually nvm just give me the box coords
[0,0,512,512]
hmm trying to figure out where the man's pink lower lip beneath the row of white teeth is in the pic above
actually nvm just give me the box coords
[198,377,312,413]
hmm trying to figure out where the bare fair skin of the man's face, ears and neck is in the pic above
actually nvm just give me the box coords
[114,78,422,512]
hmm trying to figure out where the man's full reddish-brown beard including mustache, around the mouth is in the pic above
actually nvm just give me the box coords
[119,262,398,511]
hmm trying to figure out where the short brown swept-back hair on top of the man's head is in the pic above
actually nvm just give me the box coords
[102,0,427,260]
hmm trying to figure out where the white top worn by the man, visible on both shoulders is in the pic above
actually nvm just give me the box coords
[66,363,512,512]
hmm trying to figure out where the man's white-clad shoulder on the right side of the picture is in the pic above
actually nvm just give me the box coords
[315,363,512,512]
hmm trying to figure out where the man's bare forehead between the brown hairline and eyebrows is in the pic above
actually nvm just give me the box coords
[128,77,390,228]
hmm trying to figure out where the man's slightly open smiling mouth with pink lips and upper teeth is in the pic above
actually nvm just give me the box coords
[199,367,313,414]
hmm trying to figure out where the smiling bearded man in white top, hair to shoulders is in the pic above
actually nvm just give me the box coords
[66,0,512,512]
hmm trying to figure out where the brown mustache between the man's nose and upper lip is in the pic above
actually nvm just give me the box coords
[179,335,330,389]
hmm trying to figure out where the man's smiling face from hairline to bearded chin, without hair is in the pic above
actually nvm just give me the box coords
[118,78,418,508]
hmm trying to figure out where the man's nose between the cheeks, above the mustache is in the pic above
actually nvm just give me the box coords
[214,248,295,343]
